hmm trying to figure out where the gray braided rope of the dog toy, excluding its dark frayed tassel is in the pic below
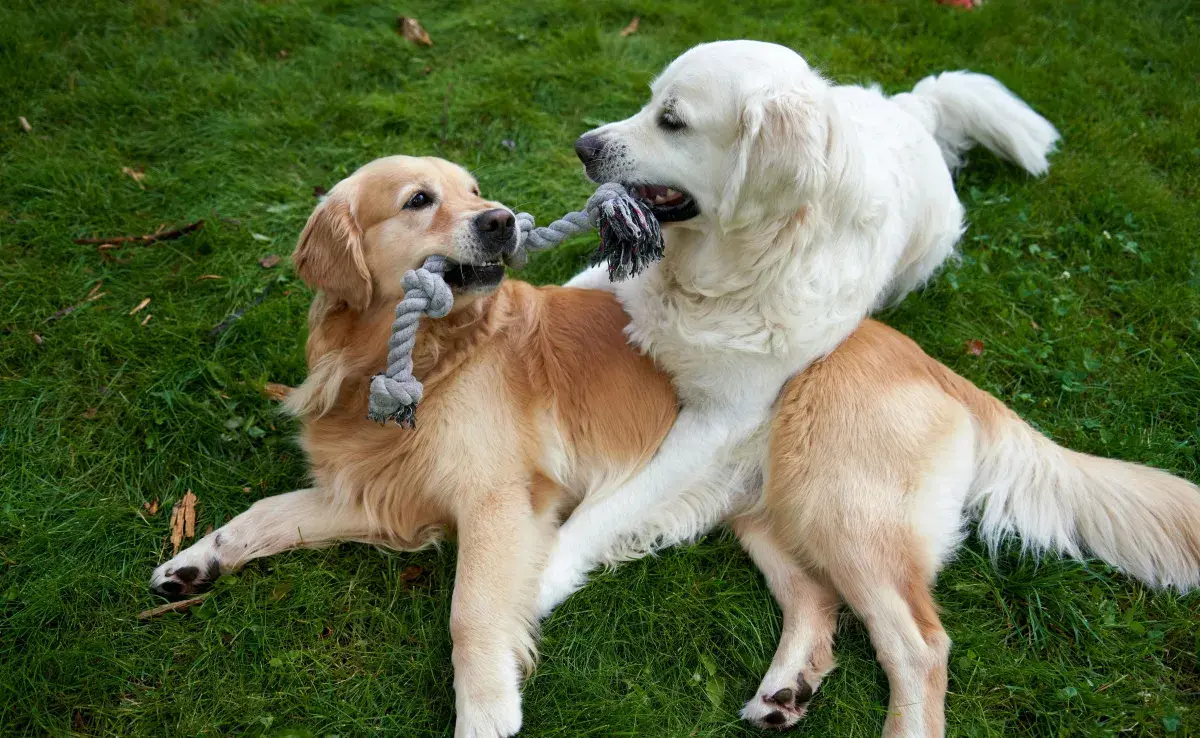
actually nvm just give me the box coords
[367,182,628,427]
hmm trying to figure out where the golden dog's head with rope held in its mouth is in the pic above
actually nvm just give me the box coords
[292,156,517,311]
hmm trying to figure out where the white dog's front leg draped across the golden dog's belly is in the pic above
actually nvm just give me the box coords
[540,407,757,617]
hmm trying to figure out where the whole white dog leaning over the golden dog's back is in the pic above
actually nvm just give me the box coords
[541,41,1057,614]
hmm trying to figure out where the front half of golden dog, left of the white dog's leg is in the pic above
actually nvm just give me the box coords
[151,156,677,738]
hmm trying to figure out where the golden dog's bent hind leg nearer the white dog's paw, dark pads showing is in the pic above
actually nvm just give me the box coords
[733,516,841,730]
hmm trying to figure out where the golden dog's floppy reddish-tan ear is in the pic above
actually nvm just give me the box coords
[292,187,371,311]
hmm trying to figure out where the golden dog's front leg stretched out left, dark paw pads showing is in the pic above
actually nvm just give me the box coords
[150,488,372,598]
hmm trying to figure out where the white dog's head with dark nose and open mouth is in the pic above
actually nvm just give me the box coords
[575,41,832,230]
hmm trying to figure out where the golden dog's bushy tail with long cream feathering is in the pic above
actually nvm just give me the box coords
[966,386,1200,590]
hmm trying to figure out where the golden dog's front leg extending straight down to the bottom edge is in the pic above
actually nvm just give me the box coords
[450,485,553,738]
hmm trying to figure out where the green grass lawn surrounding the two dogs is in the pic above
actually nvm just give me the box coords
[0,0,1200,738]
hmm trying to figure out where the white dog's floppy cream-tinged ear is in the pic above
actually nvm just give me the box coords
[718,92,826,229]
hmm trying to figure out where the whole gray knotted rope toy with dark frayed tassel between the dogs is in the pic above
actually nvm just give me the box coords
[367,182,662,428]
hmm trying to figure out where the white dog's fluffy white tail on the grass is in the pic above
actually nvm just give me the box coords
[893,72,1058,174]
